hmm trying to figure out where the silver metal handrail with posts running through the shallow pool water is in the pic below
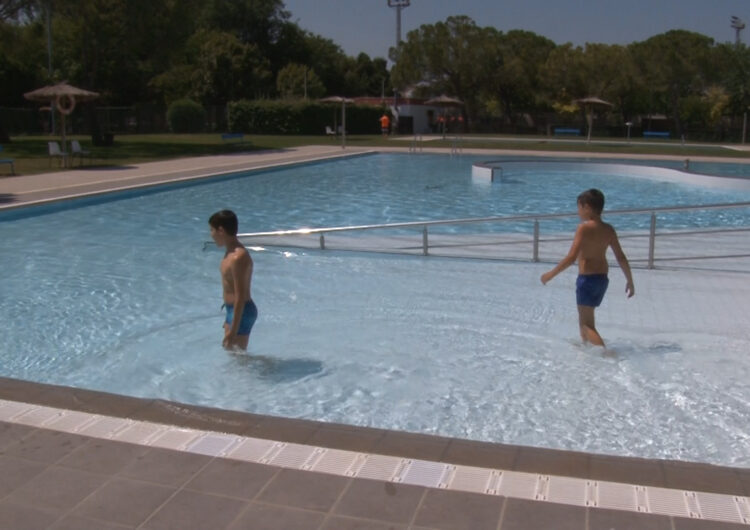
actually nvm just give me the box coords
[234,202,750,269]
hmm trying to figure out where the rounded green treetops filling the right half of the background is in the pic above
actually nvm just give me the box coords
[390,16,750,134]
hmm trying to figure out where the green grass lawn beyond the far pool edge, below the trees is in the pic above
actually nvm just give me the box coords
[0,133,750,175]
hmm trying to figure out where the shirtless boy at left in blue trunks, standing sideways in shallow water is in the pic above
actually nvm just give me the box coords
[208,210,258,350]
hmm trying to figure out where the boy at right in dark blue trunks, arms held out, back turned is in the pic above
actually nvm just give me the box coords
[541,189,635,346]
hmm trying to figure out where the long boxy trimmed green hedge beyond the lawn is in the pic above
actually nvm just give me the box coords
[227,99,383,135]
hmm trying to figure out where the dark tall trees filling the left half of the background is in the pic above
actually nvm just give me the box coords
[0,0,391,106]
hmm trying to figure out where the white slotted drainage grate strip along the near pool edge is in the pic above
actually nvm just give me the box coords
[0,399,750,526]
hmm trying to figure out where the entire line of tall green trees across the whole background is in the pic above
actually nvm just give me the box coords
[0,5,750,133]
